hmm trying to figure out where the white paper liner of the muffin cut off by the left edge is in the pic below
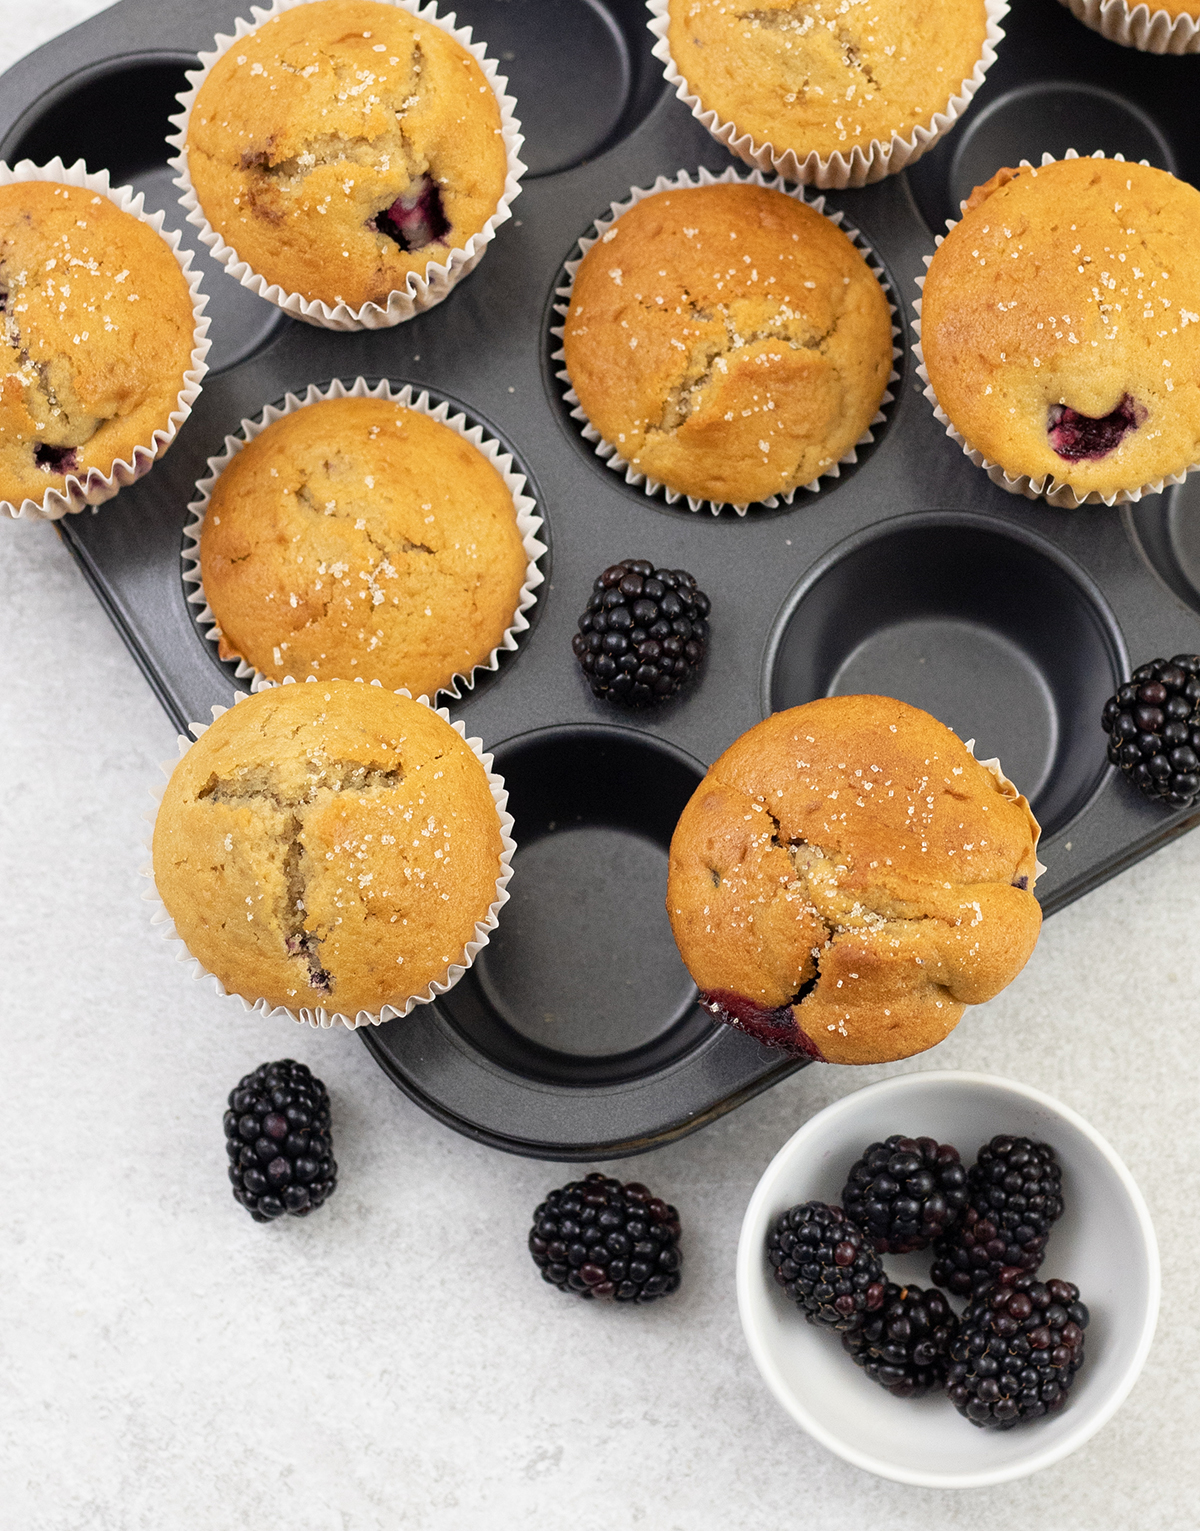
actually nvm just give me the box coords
[0,158,211,521]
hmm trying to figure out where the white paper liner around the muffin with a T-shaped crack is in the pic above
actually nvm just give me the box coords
[141,677,517,1030]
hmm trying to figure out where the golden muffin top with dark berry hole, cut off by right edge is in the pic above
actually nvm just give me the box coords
[921,159,1200,495]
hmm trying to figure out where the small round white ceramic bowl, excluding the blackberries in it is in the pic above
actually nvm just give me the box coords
[738,1072,1159,1488]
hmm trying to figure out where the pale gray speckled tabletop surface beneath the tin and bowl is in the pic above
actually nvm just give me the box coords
[0,0,1200,1531]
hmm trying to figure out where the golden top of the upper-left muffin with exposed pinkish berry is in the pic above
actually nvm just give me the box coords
[187,0,507,308]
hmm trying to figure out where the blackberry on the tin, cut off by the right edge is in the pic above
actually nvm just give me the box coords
[1101,654,1200,808]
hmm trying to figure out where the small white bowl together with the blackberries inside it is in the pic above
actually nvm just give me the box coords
[738,1072,1159,1488]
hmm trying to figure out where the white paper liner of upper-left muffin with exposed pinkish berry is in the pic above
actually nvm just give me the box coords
[167,0,527,331]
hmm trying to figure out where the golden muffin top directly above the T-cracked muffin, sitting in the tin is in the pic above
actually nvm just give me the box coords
[201,398,528,697]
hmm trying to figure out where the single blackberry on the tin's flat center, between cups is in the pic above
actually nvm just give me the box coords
[571,559,709,707]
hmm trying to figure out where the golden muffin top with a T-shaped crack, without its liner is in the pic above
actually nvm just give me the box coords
[153,681,504,1017]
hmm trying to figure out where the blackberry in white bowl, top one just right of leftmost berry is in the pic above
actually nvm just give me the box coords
[842,1136,967,1254]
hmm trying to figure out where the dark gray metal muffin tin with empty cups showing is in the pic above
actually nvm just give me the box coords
[9,0,1200,1159]
